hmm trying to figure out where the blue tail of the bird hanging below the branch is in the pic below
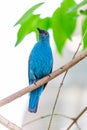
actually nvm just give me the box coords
[28,85,44,113]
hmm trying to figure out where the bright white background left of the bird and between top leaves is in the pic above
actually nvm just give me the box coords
[0,0,81,130]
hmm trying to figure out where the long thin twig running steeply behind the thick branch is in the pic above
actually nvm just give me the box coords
[48,29,87,130]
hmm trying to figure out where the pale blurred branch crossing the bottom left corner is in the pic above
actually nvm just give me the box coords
[0,115,23,130]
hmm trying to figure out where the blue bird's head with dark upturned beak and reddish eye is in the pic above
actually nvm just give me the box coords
[37,28,49,40]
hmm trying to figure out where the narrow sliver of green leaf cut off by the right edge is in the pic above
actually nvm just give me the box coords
[82,16,87,49]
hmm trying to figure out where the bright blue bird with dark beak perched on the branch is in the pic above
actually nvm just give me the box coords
[28,28,53,113]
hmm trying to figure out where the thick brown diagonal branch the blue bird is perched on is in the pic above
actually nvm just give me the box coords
[0,50,87,107]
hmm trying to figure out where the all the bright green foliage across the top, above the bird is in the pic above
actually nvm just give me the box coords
[15,0,87,53]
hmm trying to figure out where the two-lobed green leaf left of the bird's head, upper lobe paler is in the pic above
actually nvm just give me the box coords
[15,3,43,46]
